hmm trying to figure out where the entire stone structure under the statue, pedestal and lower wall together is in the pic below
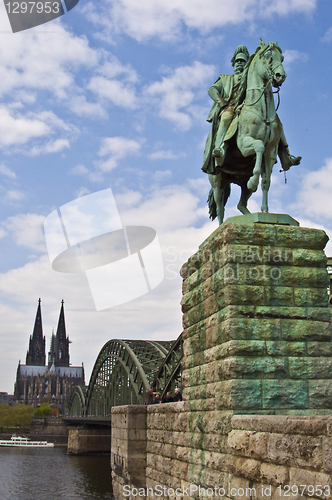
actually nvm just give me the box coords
[111,221,332,500]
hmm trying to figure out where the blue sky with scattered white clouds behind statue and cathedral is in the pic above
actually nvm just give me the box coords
[0,0,332,392]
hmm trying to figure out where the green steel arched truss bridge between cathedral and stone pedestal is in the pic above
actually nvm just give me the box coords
[69,335,183,417]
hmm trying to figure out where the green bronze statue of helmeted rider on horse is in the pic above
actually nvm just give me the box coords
[202,40,301,224]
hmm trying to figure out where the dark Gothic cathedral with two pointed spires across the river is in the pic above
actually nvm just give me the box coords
[14,299,84,411]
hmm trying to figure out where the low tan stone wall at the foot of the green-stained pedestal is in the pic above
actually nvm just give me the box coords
[112,402,332,500]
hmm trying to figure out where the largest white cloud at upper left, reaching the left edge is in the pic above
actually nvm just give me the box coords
[0,4,144,122]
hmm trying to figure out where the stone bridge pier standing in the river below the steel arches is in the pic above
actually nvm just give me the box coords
[67,427,111,455]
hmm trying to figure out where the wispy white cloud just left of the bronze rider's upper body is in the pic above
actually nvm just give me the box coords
[145,61,215,130]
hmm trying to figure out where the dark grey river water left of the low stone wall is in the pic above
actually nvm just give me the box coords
[0,447,113,500]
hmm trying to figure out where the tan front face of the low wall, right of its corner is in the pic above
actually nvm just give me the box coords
[228,415,332,498]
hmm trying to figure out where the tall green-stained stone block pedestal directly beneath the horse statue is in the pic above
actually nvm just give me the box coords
[181,222,332,415]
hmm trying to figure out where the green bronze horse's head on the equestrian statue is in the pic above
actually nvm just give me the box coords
[256,39,287,88]
